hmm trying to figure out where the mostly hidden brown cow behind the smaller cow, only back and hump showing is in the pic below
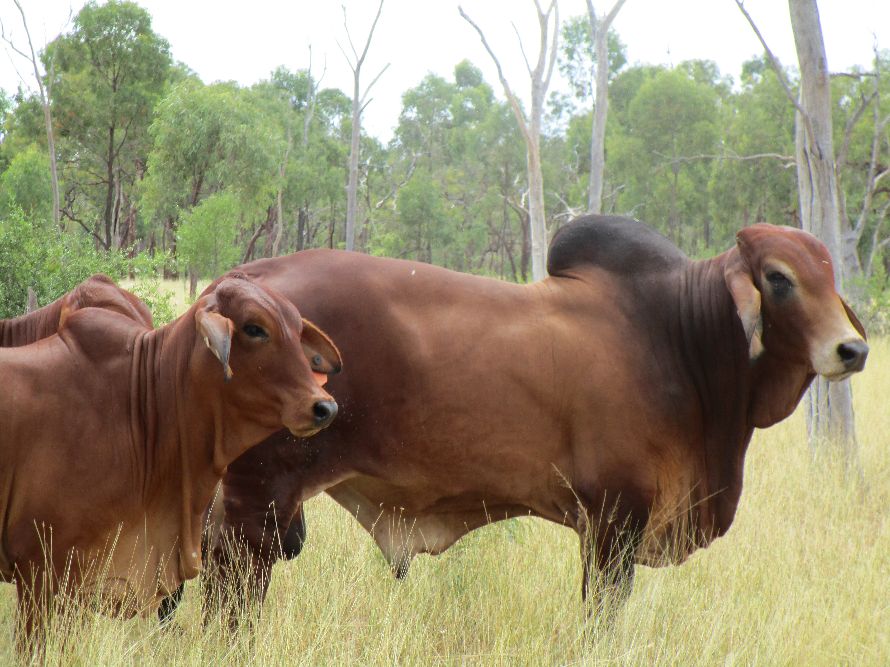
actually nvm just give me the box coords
[0,273,152,347]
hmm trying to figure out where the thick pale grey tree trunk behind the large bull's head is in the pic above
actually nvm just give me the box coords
[788,0,858,466]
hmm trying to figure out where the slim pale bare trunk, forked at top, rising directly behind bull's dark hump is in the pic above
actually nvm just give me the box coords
[587,0,626,213]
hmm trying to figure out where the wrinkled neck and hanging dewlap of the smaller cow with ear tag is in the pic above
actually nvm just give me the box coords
[131,316,226,578]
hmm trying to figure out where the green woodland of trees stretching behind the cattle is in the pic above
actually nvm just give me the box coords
[0,2,890,325]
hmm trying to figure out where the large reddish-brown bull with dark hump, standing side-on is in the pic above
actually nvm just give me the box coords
[177,216,868,620]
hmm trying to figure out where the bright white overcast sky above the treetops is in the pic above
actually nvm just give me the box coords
[0,0,890,140]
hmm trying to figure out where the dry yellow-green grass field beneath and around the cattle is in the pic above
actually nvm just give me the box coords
[0,300,890,666]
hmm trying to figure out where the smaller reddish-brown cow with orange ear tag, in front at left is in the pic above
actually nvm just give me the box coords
[0,277,340,648]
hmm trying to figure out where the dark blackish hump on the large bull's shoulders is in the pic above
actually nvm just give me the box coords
[547,215,687,276]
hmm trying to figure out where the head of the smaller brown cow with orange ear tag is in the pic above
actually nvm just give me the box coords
[195,277,341,437]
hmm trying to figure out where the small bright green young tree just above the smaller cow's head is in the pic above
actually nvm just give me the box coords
[177,192,241,278]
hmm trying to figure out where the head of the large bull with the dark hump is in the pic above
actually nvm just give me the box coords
[724,224,868,380]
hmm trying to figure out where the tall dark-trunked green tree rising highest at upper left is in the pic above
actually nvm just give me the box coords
[44,0,171,250]
